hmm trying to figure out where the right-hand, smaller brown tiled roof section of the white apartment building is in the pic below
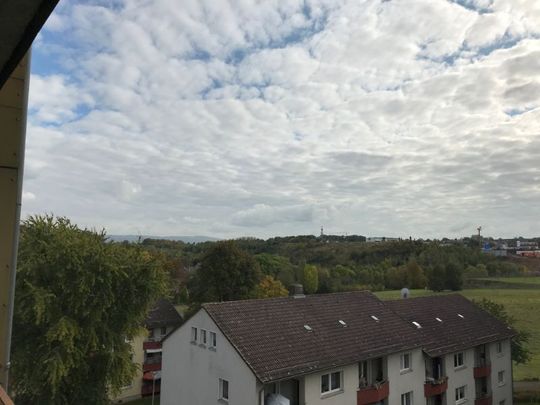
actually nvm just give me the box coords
[386,294,514,357]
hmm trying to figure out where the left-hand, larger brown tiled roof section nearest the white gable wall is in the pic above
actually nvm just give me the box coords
[203,292,422,383]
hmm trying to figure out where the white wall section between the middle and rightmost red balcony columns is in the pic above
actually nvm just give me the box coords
[443,348,476,405]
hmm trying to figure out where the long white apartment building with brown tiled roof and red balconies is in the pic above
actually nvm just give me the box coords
[161,292,513,405]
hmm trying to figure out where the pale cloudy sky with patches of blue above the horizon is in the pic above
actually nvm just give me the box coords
[23,0,540,238]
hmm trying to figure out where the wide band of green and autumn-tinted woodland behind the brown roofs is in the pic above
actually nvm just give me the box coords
[137,235,526,303]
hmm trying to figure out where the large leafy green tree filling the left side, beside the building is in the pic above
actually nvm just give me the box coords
[12,216,166,405]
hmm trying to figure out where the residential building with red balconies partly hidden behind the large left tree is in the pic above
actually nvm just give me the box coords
[113,299,182,403]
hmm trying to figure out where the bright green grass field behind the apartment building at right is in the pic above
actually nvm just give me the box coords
[375,286,540,381]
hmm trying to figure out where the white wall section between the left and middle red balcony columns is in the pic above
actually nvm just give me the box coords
[387,349,426,404]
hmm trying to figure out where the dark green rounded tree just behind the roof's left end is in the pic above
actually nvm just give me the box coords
[189,241,261,305]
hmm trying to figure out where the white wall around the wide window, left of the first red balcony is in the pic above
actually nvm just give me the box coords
[300,364,358,405]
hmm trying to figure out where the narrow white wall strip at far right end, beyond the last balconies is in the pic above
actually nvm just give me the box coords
[488,340,512,405]
